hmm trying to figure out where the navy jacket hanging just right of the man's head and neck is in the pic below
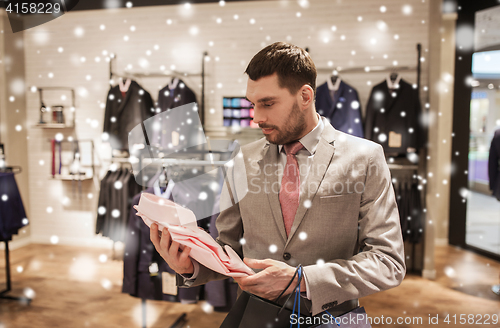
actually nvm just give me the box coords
[316,79,364,138]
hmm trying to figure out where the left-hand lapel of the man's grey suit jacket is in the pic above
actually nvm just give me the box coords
[259,143,286,241]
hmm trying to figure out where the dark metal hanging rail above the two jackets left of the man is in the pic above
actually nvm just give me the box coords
[109,51,208,126]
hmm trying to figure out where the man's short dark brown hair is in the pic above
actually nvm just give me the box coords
[245,42,316,96]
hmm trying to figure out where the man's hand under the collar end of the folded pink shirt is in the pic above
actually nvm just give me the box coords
[150,223,194,274]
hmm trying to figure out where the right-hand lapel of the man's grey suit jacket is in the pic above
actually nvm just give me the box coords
[286,118,335,248]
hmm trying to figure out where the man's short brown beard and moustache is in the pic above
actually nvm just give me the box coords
[259,102,306,145]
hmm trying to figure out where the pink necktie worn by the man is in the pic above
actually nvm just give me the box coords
[279,141,304,236]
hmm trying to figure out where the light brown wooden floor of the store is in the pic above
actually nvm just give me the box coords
[0,245,500,328]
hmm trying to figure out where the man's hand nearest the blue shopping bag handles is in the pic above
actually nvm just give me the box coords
[234,258,306,301]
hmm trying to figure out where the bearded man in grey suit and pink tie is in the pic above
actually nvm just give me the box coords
[151,42,406,316]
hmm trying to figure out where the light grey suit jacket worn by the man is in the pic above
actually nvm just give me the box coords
[178,118,406,315]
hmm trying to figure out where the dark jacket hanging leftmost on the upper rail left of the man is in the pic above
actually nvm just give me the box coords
[103,81,155,150]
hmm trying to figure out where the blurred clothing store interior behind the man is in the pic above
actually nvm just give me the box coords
[0,0,500,328]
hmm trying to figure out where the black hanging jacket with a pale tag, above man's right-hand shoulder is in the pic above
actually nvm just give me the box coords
[364,79,425,156]
